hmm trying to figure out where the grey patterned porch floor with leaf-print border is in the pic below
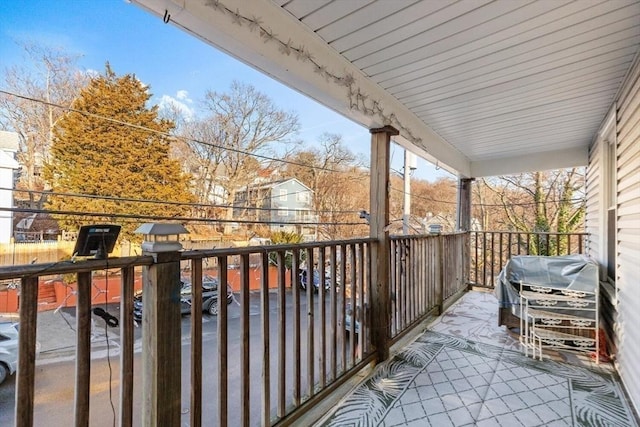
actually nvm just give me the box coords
[320,292,637,427]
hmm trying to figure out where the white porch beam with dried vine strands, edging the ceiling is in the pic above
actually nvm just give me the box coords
[133,0,470,176]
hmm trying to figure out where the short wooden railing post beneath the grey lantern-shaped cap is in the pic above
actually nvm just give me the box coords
[142,252,181,427]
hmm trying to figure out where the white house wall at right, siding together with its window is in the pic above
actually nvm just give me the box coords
[587,55,640,416]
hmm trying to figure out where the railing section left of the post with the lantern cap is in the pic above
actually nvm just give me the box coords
[0,256,153,426]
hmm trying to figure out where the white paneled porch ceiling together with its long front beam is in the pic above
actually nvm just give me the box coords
[134,0,640,177]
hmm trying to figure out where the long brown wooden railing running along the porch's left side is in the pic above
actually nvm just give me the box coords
[0,234,468,426]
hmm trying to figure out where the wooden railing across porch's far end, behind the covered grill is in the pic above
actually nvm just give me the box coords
[469,231,587,288]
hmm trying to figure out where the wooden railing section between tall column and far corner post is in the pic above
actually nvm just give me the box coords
[389,233,468,340]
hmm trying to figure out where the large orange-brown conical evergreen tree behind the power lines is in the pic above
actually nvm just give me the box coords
[44,64,194,238]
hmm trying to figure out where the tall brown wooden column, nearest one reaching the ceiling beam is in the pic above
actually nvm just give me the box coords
[369,126,399,362]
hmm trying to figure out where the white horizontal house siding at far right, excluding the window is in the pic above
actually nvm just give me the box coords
[602,52,640,409]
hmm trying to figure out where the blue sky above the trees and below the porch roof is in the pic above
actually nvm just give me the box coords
[0,0,451,180]
